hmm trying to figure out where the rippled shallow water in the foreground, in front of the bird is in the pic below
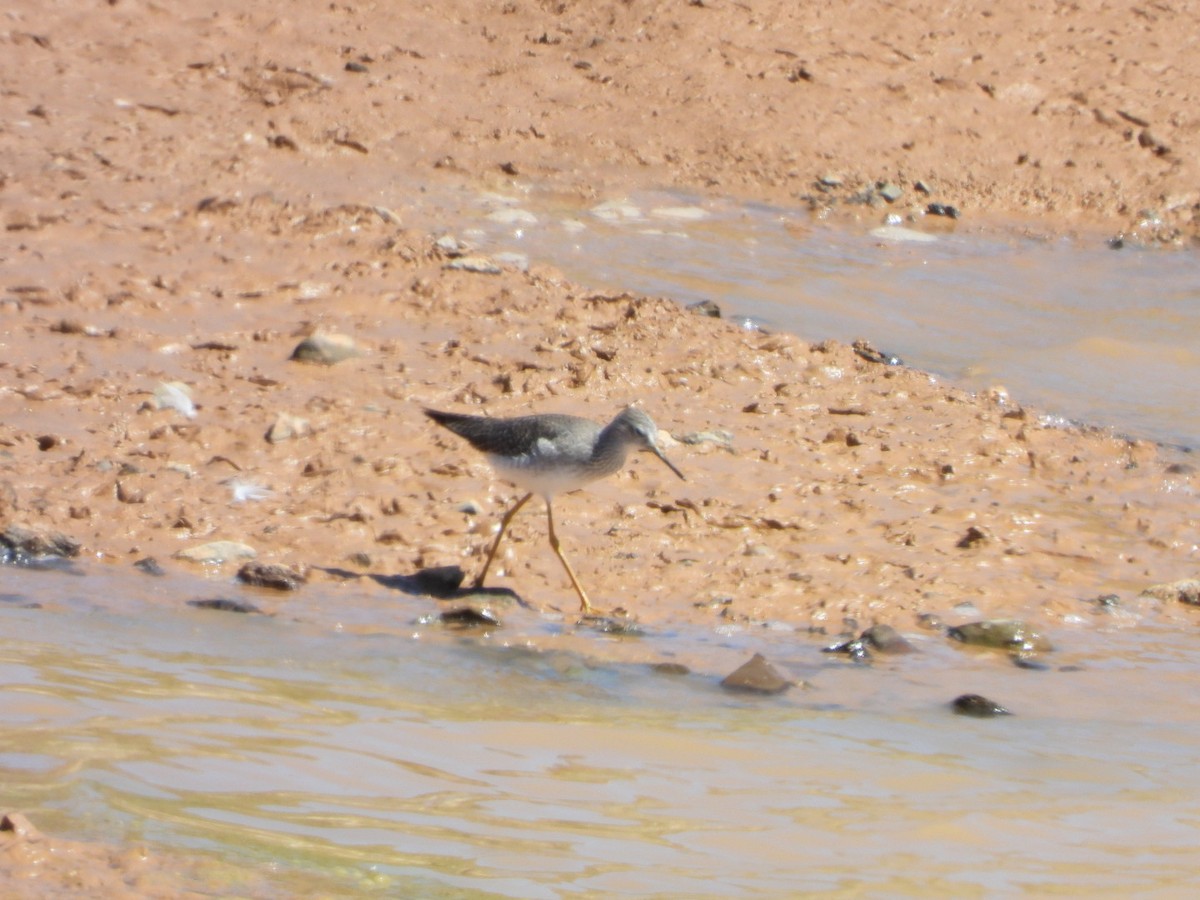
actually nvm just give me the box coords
[0,566,1200,898]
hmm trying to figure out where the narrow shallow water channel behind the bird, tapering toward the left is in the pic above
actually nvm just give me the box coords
[448,192,1200,446]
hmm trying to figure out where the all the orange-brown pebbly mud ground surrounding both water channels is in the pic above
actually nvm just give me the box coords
[0,2,1200,896]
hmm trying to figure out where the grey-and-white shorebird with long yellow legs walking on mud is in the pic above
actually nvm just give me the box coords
[425,407,686,614]
